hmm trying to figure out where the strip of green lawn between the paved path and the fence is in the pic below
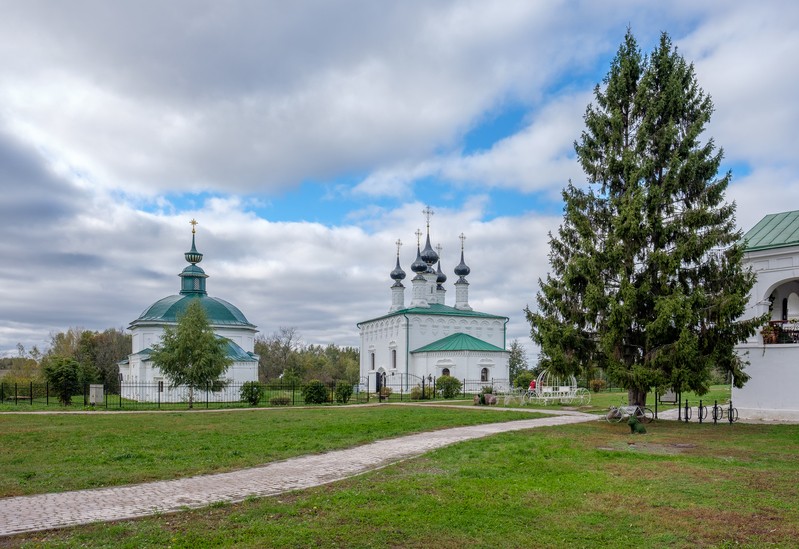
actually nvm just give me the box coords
[0,404,535,497]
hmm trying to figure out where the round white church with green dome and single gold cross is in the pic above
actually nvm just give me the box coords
[119,220,258,402]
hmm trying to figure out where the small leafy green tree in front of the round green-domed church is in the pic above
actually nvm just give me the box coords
[150,300,232,408]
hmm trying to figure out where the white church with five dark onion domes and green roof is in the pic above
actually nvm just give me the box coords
[358,208,509,391]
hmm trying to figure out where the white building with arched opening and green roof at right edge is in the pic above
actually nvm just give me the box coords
[732,211,799,420]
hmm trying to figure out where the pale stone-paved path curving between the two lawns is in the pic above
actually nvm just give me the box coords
[0,410,599,536]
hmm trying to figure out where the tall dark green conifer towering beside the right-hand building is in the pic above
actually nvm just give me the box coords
[526,30,763,405]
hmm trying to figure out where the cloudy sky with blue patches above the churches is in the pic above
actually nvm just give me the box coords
[0,0,799,361]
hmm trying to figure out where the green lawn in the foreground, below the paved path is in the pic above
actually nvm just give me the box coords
[14,421,799,548]
